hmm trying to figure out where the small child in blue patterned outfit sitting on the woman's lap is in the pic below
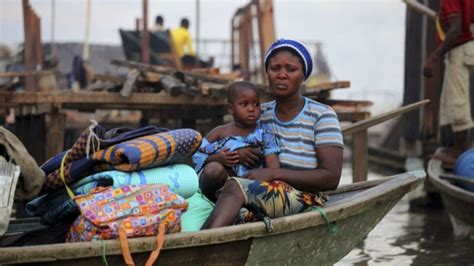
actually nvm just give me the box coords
[193,81,280,201]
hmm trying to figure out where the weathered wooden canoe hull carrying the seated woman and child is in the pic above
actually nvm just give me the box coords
[0,171,425,266]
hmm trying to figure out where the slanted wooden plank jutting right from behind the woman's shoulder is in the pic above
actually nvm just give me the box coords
[341,100,430,135]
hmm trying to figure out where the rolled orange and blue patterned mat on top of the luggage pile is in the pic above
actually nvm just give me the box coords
[92,129,202,171]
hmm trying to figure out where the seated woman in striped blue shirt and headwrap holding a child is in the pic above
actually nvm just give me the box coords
[201,39,343,228]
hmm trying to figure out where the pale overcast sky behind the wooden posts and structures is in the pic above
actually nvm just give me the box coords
[0,0,406,113]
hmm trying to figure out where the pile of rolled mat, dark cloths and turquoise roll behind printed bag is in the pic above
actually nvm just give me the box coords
[26,123,202,225]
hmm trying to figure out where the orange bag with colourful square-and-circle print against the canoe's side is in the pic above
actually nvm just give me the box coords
[66,185,187,242]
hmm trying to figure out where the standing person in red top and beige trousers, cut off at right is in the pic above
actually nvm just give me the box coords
[423,0,474,167]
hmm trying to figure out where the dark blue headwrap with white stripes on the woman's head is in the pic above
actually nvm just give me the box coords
[264,39,313,80]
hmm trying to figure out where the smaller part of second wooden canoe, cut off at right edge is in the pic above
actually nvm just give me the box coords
[428,159,474,238]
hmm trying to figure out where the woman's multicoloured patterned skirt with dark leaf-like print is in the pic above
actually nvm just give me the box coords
[228,177,327,223]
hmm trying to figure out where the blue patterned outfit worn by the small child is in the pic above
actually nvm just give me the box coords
[193,123,280,176]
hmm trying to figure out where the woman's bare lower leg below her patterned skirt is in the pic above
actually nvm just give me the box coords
[201,180,245,229]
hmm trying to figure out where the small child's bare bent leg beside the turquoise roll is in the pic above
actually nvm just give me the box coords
[199,162,228,202]
